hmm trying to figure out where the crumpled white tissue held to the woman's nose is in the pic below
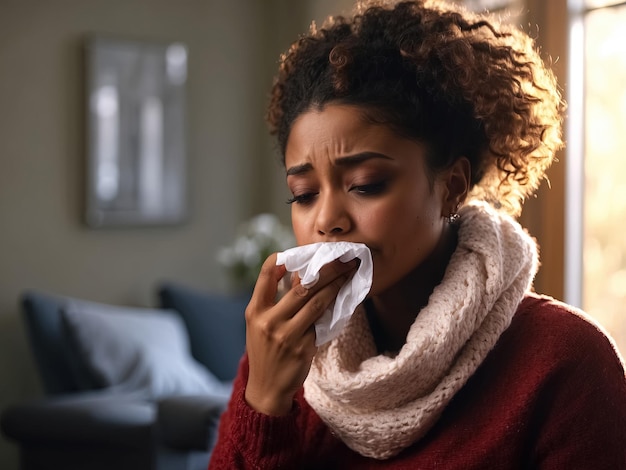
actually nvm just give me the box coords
[276,242,373,346]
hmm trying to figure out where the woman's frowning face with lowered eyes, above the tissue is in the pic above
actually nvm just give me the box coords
[285,105,451,295]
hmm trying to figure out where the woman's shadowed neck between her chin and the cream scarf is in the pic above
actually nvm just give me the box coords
[366,225,457,353]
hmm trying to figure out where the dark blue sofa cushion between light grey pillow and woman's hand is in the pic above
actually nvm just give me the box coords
[159,283,250,380]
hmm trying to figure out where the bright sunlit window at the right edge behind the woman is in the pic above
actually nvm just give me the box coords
[565,0,626,352]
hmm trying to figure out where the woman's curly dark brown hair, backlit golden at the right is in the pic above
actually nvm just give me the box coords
[267,0,564,215]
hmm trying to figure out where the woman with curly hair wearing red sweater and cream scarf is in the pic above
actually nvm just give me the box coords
[211,1,626,469]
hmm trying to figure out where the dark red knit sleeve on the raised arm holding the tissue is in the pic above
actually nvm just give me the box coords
[209,356,301,470]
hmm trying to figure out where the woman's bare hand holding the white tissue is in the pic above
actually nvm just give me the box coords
[245,254,358,415]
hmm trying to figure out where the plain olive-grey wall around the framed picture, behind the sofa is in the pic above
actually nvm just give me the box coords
[0,0,310,469]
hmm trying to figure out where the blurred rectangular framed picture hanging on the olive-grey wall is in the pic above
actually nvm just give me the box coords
[85,35,187,228]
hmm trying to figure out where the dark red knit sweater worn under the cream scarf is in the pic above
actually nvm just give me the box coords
[209,295,626,470]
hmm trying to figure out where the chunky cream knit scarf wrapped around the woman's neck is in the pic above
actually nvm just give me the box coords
[304,203,538,459]
